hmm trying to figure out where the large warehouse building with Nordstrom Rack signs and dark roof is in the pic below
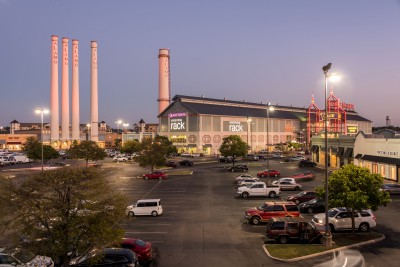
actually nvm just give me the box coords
[159,95,372,155]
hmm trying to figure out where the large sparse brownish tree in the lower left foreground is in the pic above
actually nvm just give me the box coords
[0,168,127,265]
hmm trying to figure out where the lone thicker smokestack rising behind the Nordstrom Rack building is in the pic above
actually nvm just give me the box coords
[158,48,170,114]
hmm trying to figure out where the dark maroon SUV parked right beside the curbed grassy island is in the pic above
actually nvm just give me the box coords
[265,217,325,244]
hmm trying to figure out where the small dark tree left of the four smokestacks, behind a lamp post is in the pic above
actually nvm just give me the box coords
[22,136,60,162]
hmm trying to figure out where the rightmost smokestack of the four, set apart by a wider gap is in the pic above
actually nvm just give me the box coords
[90,41,99,142]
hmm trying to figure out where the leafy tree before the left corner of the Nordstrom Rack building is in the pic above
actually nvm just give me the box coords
[134,139,168,171]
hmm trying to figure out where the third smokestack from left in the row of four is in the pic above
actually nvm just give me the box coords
[71,40,80,140]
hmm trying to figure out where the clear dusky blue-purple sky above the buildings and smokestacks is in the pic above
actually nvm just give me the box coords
[0,0,400,128]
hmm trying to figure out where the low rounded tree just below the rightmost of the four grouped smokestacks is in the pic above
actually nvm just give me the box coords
[69,141,107,167]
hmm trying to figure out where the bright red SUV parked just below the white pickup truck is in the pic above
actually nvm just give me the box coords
[244,201,300,225]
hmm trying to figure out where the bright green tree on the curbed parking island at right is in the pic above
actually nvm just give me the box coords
[316,164,390,232]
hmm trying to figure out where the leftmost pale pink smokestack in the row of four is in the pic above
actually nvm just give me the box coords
[50,35,60,141]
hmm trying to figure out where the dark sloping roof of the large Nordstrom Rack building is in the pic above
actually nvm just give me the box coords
[159,95,370,121]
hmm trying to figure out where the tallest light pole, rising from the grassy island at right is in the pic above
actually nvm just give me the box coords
[322,63,332,248]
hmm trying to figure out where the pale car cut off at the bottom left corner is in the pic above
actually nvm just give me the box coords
[0,248,54,267]
